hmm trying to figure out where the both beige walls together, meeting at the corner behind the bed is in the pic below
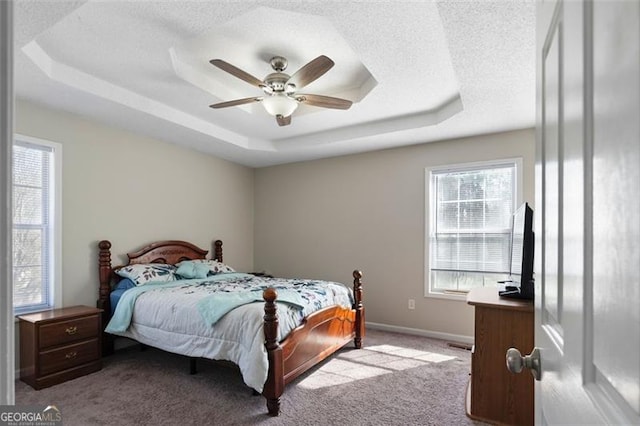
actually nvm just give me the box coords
[10,102,534,358]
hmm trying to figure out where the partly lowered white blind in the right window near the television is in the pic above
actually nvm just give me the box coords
[430,164,515,273]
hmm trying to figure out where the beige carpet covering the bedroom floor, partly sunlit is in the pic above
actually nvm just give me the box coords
[16,330,482,426]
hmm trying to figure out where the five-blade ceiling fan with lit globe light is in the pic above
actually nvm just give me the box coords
[209,55,352,126]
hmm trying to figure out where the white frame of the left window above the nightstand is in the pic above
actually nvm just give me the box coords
[12,134,62,315]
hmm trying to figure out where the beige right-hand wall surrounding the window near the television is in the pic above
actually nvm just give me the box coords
[254,129,534,337]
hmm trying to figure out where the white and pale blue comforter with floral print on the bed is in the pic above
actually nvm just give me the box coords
[106,274,353,392]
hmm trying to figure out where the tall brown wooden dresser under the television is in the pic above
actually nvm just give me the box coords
[467,287,534,425]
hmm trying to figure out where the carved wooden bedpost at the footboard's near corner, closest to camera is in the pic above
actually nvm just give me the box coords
[262,288,284,416]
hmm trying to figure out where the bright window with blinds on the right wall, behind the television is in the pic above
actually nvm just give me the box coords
[425,159,522,297]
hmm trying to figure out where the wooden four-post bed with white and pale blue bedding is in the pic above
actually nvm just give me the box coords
[97,240,365,416]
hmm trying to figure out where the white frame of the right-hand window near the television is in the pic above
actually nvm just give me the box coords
[424,157,523,301]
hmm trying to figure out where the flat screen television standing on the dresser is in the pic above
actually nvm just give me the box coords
[499,203,534,299]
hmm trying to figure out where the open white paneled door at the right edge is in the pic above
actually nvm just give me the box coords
[535,0,640,424]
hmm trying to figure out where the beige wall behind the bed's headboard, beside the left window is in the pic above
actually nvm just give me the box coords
[15,102,254,306]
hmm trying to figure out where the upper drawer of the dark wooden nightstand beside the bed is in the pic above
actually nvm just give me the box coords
[39,315,100,349]
